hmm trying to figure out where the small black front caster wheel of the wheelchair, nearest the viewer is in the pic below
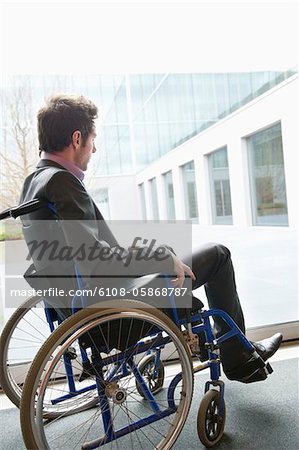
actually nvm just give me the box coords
[197,389,226,448]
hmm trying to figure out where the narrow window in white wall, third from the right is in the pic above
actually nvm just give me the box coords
[181,161,198,222]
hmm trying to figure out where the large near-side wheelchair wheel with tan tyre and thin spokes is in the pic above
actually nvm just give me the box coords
[21,299,193,450]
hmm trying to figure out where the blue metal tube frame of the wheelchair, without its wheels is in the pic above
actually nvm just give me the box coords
[0,199,255,450]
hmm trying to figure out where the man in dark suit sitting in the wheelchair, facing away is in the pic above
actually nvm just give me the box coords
[20,95,282,383]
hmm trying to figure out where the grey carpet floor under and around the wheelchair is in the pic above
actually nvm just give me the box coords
[0,359,299,450]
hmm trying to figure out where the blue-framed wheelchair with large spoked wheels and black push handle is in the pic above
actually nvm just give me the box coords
[0,200,272,450]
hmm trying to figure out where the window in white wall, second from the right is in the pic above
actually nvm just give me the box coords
[208,147,233,225]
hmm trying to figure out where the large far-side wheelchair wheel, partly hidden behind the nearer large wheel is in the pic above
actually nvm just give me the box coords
[0,297,50,407]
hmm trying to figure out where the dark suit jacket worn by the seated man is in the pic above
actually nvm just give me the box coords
[20,160,173,298]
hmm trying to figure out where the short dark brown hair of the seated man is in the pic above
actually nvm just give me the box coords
[37,95,98,153]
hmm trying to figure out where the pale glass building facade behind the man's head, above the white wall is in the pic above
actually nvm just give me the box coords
[1,69,297,176]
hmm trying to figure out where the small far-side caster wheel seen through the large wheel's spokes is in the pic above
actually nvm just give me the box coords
[136,355,165,397]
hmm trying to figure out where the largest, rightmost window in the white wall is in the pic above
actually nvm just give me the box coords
[247,123,288,226]
